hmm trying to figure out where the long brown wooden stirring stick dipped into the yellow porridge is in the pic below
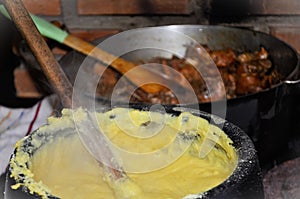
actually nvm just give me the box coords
[5,0,134,187]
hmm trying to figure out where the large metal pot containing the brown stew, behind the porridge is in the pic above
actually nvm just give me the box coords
[60,25,299,168]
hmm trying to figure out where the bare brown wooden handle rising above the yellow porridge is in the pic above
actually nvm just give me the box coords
[5,0,73,108]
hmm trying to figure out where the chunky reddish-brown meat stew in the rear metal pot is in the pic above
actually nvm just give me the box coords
[95,46,282,104]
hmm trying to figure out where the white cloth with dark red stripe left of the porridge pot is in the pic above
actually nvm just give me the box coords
[0,96,56,175]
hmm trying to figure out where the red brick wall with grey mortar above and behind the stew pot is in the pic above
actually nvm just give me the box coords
[17,0,300,52]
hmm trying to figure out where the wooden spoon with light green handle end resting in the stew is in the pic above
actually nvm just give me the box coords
[0,5,191,93]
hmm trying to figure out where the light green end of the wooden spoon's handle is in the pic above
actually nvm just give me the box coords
[0,5,68,43]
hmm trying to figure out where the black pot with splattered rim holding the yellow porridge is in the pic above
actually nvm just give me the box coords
[5,106,263,199]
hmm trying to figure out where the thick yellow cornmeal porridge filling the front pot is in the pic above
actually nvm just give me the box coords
[10,108,238,199]
